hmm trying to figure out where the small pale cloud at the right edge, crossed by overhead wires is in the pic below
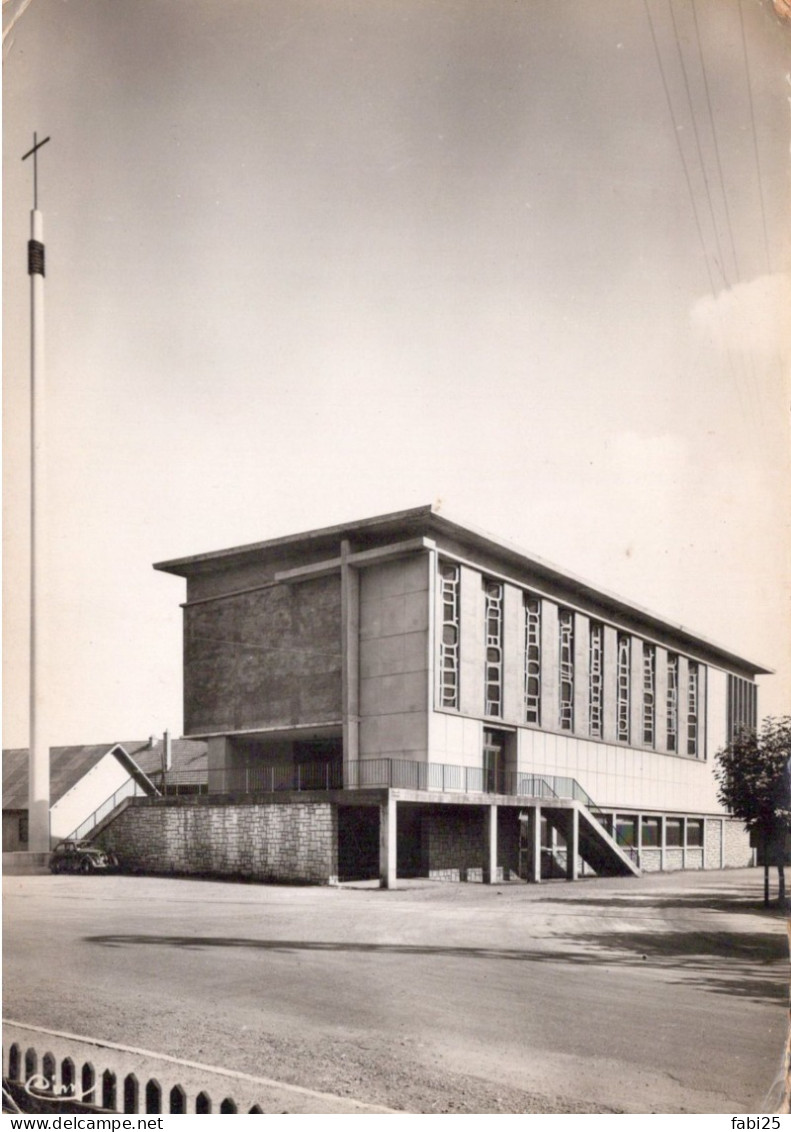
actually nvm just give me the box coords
[690,273,791,368]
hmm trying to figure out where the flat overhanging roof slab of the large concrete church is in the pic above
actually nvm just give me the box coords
[154,504,773,676]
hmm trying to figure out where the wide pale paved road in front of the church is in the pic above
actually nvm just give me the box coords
[3,871,789,1113]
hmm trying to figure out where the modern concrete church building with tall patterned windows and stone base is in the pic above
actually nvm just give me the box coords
[96,507,768,886]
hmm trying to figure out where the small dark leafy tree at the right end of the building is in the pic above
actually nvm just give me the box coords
[714,715,791,904]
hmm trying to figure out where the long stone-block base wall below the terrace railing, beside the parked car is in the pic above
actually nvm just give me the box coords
[97,798,337,884]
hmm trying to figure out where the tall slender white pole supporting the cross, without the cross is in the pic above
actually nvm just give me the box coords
[27,207,50,852]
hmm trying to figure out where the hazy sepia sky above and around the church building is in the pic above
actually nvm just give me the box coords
[3,0,791,746]
